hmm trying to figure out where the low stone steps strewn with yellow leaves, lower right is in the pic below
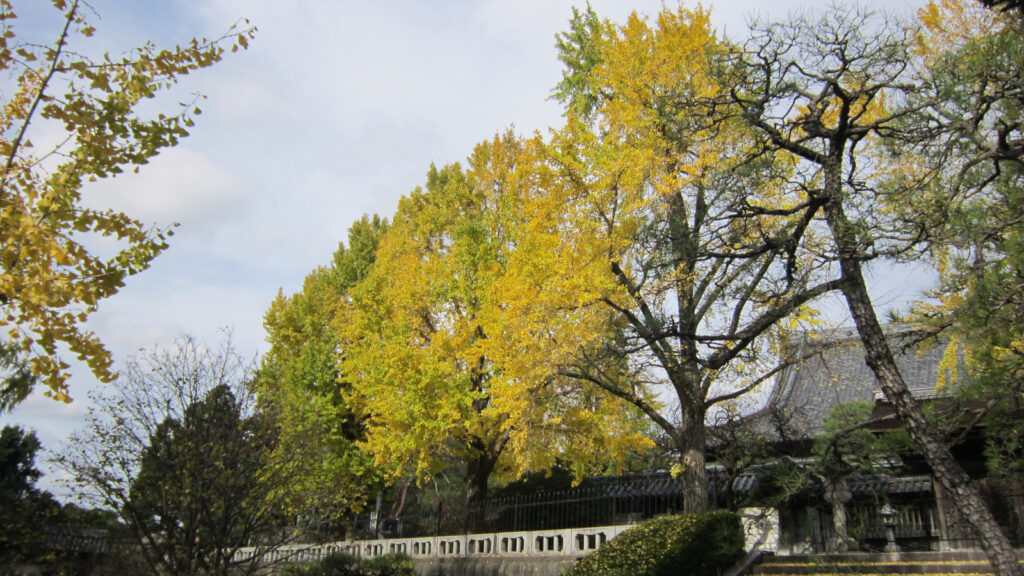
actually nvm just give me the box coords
[748,551,1019,576]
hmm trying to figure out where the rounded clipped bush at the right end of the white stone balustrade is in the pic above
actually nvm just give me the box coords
[566,510,743,576]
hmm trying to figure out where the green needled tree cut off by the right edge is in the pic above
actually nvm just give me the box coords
[912,0,1024,478]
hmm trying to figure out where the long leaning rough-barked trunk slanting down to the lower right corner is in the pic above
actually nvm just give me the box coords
[825,199,1024,576]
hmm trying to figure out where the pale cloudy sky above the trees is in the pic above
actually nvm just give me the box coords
[0,0,921,495]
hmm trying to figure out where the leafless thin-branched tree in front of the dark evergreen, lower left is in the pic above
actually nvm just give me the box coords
[56,336,287,574]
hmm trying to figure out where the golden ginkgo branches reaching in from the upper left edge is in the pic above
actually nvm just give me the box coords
[0,0,255,401]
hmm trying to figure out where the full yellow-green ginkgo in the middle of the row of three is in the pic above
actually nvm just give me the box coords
[339,133,648,506]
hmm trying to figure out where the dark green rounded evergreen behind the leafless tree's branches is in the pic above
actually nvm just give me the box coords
[126,384,272,574]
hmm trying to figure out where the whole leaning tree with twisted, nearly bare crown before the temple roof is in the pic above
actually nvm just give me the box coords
[729,3,1024,574]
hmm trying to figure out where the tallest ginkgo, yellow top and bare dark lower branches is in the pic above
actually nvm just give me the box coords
[538,8,838,512]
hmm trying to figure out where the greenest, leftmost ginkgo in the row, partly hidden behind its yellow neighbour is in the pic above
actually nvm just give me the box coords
[253,216,388,520]
